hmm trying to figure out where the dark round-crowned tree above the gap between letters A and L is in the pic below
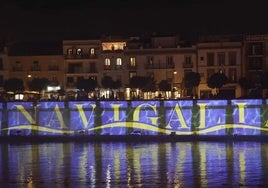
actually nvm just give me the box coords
[184,72,201,96]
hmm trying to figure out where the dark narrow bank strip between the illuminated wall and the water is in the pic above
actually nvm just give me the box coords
[0,135,268,143]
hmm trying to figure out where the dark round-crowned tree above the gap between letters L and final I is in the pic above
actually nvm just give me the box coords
[207,73,228,94]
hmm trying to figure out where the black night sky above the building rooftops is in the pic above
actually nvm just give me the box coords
[0,0,268,40]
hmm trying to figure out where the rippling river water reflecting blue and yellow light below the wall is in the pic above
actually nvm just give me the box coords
[0,142,268,188]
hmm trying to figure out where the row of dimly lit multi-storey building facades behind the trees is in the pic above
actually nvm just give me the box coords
[0,35,268,99]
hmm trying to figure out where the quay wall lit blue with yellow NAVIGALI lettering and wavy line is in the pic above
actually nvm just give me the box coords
[0,99,268,135]
